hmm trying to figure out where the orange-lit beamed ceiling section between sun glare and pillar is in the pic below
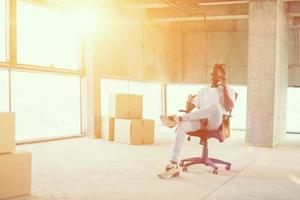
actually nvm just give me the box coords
[118,0,249,22]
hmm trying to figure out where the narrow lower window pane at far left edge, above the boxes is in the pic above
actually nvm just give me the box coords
[0,70,9,112]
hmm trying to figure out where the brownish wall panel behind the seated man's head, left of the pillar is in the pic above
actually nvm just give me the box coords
[183,31,248,84]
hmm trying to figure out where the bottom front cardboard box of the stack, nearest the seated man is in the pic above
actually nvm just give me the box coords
[115,119,154,144]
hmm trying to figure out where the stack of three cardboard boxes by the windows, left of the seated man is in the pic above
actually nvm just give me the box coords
[102,94,154,144]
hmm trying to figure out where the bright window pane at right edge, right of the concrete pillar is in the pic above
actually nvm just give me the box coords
[286,88,300,133]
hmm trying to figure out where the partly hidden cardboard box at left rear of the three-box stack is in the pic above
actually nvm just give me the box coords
[101,117,115,141]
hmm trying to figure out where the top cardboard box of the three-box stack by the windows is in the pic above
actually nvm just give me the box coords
[110,94,143,119]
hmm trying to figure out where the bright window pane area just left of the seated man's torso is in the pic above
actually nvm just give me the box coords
[167,84,207,115]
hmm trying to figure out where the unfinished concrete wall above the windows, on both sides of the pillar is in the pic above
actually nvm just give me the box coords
[94,4,300,86]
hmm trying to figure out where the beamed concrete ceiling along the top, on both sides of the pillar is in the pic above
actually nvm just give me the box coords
[36,0,300,25]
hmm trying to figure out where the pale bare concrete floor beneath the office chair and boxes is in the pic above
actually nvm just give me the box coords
[14,128,300,200]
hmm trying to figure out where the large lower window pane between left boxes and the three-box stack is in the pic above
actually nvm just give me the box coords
[12,72,81,140]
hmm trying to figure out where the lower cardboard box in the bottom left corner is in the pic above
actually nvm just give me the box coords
[0,152,31,199]
